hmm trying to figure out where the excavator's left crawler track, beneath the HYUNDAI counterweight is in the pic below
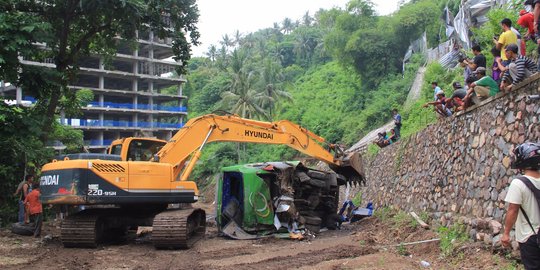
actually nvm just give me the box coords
[61,213,103,248]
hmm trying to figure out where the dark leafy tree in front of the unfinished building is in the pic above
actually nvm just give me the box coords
[0,0,199,224]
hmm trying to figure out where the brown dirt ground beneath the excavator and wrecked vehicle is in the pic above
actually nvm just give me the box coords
[0,205,513,270]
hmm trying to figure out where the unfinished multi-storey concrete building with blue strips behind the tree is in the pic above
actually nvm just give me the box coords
[3,31,187,152]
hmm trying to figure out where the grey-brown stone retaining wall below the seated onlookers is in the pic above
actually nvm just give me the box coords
[362,75,540,225]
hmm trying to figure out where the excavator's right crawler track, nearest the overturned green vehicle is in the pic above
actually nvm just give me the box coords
[152,209,206,249]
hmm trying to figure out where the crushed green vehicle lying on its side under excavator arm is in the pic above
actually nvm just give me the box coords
[216,162,346,239]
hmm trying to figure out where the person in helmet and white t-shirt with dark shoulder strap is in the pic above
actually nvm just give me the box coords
[501,142,540,269]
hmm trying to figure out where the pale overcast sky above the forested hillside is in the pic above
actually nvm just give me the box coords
[193,0,398,56]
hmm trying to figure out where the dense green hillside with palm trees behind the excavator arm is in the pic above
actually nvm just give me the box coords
[186,0,459,182]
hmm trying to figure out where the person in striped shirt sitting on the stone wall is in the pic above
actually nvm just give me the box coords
[501,44,538,91]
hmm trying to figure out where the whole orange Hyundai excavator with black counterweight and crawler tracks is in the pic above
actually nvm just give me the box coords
[40,114,364,248]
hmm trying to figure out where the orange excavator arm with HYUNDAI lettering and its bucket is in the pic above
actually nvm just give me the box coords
[154,114,364,182]
